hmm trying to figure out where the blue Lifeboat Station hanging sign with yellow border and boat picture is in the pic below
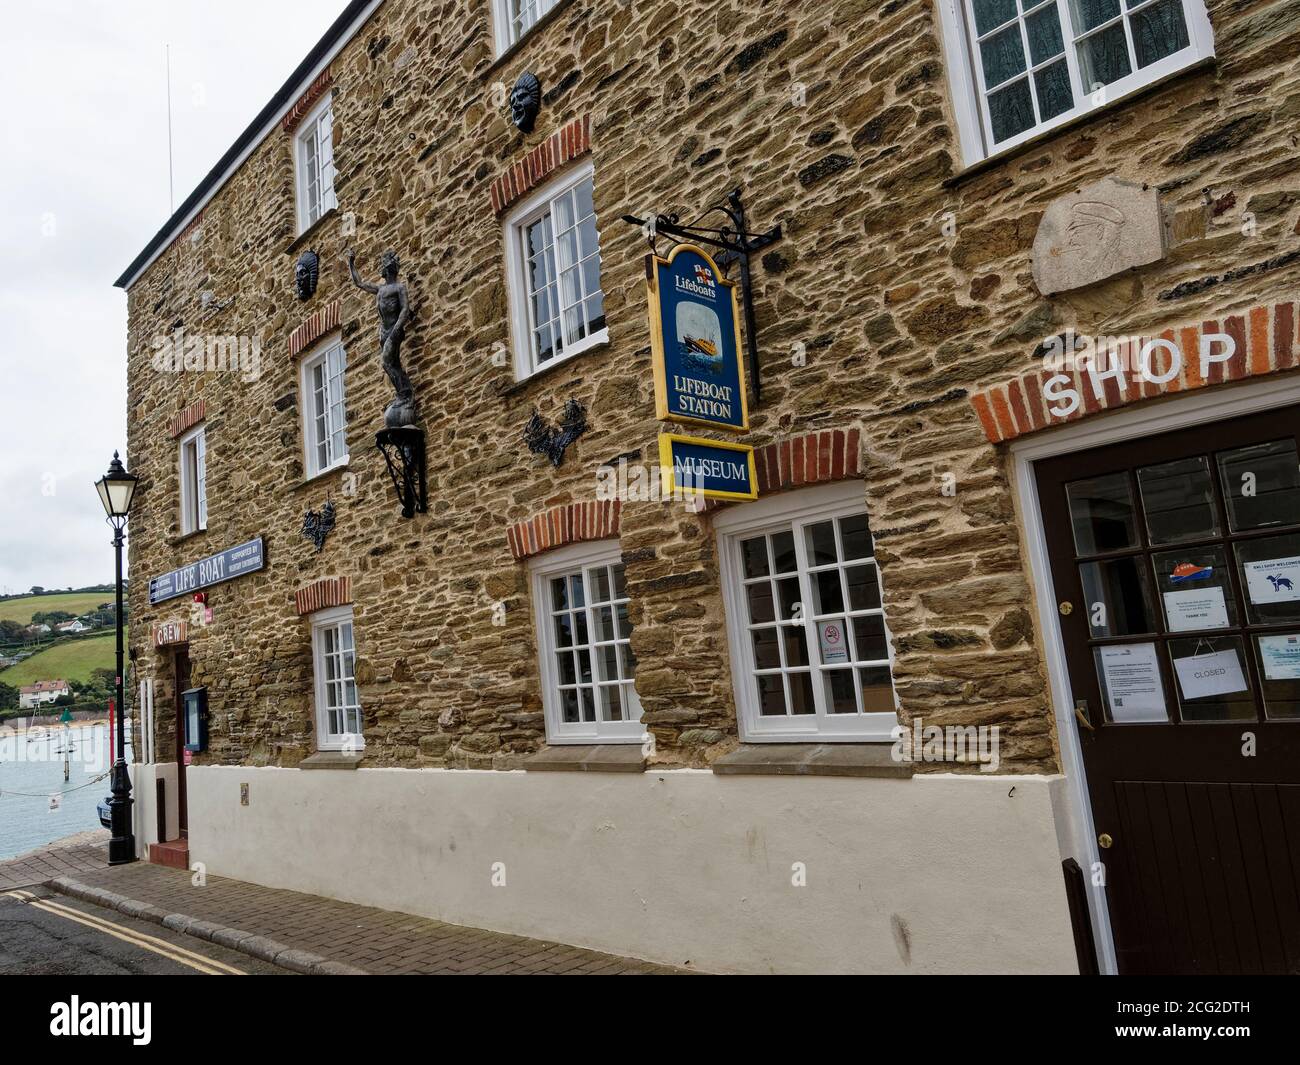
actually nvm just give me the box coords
[646,244,749,433]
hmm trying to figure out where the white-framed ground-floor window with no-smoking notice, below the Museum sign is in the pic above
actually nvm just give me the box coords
[714,481,897,743]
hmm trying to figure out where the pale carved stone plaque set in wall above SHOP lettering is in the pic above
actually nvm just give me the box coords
[1034,177,1165,295]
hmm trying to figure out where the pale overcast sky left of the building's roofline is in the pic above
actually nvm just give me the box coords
[0,0,346,593]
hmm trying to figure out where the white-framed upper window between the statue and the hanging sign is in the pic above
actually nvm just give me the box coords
[506,164,608,378]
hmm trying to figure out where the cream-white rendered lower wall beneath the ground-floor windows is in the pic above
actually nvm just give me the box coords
[186,766,1078,973]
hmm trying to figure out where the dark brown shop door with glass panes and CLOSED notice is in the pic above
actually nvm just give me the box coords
[1036,407,1300,973]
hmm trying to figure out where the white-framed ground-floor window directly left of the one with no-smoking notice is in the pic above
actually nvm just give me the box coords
[532,541,645,744]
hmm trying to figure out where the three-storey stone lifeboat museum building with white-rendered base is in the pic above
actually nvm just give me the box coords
[118,0,1300,973]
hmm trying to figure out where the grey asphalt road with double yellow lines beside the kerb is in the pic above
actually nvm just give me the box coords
[0,888,294,977]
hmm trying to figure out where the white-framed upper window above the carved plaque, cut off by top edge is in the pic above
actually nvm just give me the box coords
[937,0,1214,164]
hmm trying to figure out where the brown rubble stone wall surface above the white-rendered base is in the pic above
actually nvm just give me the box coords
[129,0,1300,771]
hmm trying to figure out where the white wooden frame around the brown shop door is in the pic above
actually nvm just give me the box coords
[1010,375,1300,974]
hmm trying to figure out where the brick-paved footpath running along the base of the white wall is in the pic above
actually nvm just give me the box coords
[55,862,680,975]
